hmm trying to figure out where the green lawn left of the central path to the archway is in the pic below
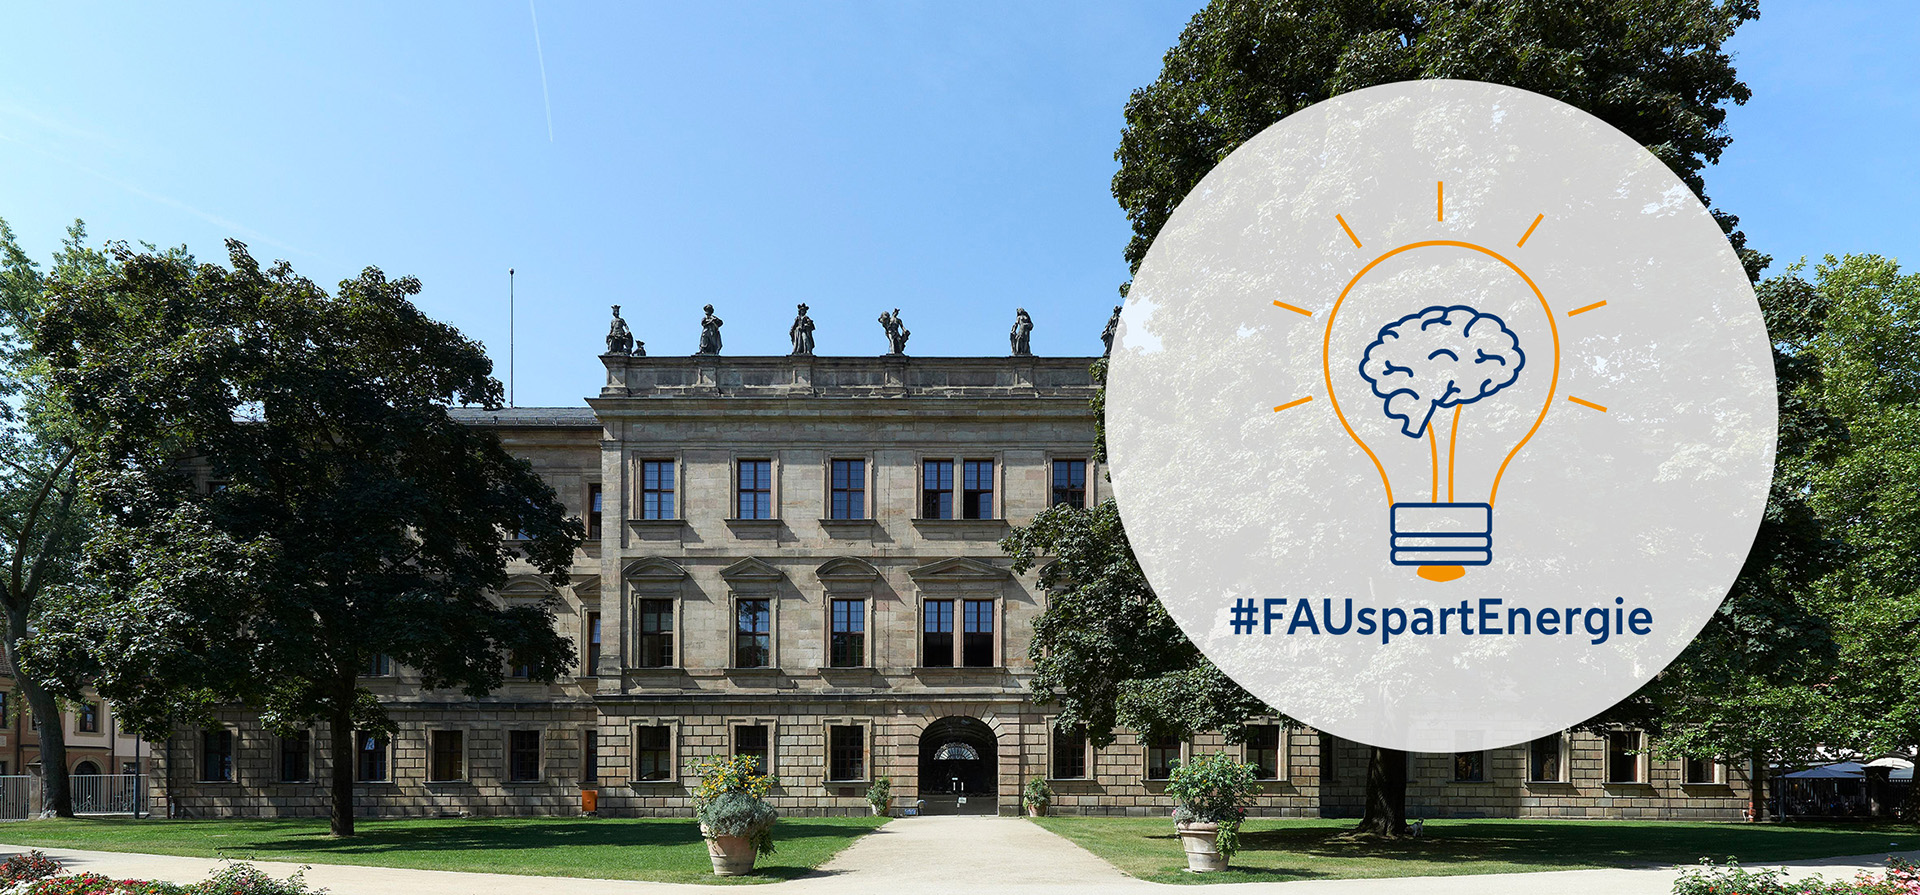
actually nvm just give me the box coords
[0,816,885,883]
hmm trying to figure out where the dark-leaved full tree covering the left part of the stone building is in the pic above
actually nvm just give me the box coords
[35,242,582,835]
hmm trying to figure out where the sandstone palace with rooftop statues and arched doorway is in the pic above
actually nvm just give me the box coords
[154,307,1745,820]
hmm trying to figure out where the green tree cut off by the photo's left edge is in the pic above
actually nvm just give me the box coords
[0,221,104,816]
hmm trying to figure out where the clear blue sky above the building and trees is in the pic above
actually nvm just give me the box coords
[0,0,1920,405]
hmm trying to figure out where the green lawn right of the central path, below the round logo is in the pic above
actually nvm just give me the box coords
[1037,818,1920,883]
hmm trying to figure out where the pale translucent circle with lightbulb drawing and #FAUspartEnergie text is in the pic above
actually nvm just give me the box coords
[1106,81,1776,753]
